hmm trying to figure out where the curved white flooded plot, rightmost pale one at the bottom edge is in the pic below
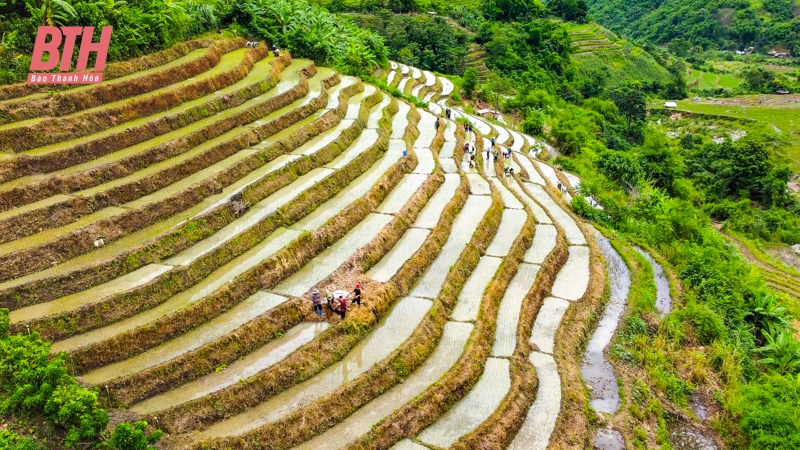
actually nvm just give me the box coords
[508,352,561,450]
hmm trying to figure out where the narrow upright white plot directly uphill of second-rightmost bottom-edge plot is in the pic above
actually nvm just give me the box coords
[492,263,540,356]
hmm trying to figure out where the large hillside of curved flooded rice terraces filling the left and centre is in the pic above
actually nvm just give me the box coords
[0,40,603,449]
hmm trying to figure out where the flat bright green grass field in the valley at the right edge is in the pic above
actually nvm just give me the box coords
[678,97,800,171]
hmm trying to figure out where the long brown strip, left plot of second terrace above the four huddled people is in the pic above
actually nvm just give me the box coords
[51,228,299,353]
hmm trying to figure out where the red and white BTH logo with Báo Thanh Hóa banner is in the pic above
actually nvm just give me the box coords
[28,27,112,84]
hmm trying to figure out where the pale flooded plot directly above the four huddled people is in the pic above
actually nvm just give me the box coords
[273,214,394,297]
